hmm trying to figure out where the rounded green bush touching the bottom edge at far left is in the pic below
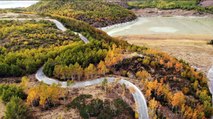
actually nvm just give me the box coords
[5,97,30,119]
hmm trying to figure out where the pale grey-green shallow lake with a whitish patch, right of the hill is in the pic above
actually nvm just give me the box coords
[103,16,213,36]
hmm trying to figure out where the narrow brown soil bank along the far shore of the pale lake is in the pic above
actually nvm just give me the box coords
[132,8,213,17]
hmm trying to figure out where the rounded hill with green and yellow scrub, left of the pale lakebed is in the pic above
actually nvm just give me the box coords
[29,0,136,27]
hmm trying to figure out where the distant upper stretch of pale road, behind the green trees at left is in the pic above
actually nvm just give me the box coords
[0,18,89,44]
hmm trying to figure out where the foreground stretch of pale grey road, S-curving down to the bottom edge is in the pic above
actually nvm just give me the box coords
[35,68,149,119]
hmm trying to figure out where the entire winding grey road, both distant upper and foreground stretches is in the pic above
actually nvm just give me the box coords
[0,18,149,119]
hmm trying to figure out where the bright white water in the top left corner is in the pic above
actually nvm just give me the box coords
[0,1,38,9]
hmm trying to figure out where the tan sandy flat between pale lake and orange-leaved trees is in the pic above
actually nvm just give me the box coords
[120,35,213,73]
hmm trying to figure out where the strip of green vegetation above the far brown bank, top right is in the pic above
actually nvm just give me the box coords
[128,0,213,13]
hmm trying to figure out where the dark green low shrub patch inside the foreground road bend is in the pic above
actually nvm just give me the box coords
[68,95,134,119]
